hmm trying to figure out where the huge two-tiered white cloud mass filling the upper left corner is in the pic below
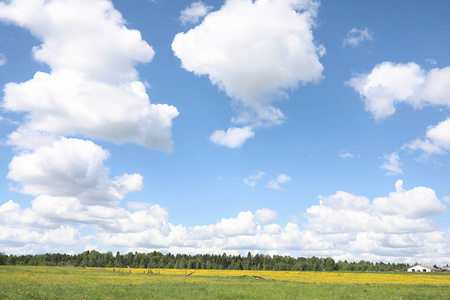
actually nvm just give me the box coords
[0,0,178,150]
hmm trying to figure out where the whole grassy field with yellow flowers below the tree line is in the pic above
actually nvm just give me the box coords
[0,266,450,299]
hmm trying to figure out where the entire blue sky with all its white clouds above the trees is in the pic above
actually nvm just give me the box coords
[0,0,450,264]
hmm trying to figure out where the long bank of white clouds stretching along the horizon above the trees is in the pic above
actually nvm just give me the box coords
[0,181,450,263]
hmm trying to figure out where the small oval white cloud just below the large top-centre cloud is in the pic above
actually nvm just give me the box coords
[210,126,255,148]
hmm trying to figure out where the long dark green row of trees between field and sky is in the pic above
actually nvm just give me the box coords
[0,250,409,272]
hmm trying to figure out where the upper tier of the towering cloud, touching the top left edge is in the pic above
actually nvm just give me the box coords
[0,0,154,82]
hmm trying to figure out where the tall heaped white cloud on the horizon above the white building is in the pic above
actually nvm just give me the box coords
[302,181,450,263]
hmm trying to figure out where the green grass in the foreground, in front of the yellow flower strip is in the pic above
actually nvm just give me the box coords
[0,266,450,299]
